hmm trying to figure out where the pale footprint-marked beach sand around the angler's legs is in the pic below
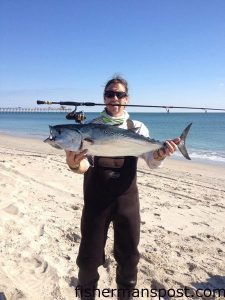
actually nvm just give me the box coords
[0,135,225,300]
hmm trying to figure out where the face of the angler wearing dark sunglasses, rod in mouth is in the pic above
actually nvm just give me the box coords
[104,83,128,117]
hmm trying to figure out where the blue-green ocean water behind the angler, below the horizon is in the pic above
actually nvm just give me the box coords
[0,112,225,167]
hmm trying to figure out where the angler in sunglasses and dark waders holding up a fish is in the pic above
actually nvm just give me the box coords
[66,76,180,300]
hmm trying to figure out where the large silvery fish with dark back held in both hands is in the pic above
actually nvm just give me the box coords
[44,123,192,160]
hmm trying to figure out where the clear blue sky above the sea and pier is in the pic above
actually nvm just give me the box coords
[0,0,225,109]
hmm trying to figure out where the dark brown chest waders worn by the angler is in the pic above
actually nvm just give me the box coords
[77,120,140,300]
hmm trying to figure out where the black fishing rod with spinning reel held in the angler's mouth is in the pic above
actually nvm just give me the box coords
[37,100,225,123]
